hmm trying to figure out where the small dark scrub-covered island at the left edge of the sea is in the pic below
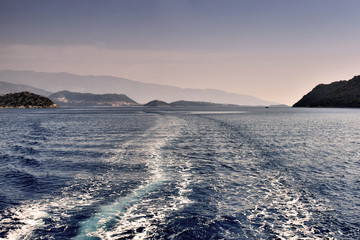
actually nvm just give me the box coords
[0,92,59,108]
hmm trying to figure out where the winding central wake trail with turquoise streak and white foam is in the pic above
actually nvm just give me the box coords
[74,117,194,239]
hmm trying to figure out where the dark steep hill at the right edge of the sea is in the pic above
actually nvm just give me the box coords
[293,75,360,108]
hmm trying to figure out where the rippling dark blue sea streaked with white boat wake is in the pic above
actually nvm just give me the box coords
[0,107,360,240]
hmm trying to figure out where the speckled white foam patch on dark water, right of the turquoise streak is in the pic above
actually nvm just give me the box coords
[247,172,333,239]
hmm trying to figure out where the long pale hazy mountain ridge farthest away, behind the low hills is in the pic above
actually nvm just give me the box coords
[0,70,277,106]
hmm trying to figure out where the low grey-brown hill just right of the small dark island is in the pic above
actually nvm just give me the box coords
[49,91,138,107]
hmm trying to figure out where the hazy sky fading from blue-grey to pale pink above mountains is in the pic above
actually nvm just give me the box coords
[0,0,360,105]
